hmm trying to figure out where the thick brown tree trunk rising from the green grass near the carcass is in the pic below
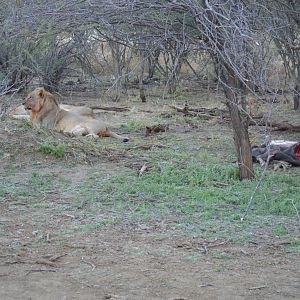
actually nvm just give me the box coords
[223,74,253,180]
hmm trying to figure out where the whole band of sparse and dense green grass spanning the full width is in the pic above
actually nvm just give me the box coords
[0,148,300,244]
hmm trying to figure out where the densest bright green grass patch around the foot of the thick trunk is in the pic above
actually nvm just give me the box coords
[98,162,299,218]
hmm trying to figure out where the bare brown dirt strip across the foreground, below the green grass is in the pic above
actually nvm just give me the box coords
[0,224,300,299]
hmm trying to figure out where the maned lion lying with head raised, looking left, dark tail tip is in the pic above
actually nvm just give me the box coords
[23,88,128,142]
